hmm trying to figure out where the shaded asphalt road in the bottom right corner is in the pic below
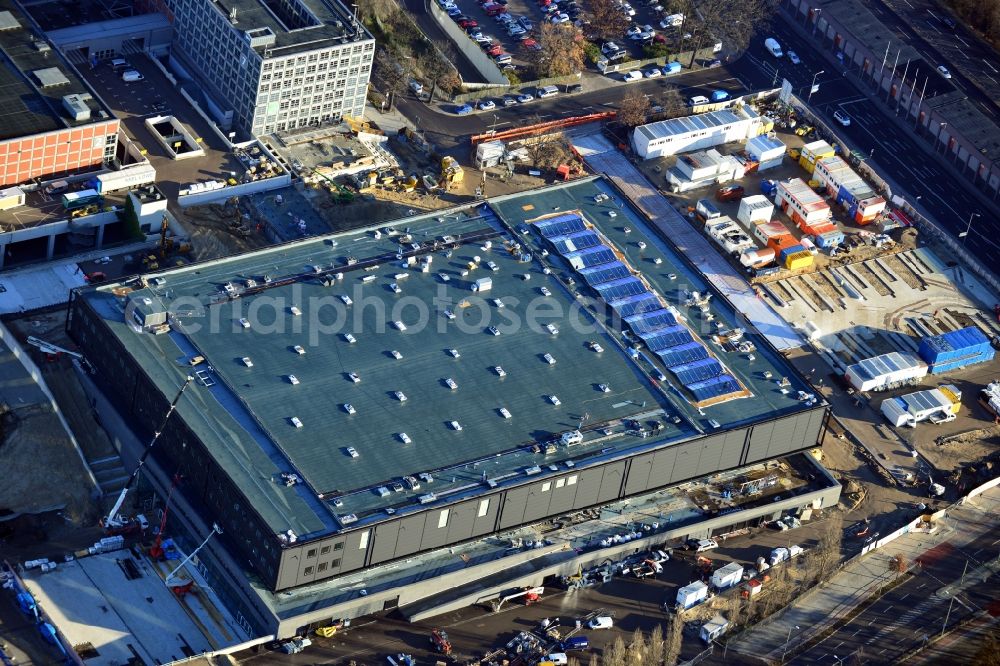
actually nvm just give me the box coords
[789,529,1000,664]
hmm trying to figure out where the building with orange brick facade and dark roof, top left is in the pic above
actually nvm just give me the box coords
[0,0,118,187]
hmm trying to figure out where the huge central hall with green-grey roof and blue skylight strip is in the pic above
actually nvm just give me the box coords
[68,179,836,633]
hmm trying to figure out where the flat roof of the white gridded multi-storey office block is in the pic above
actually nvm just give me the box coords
[211,0,372,58]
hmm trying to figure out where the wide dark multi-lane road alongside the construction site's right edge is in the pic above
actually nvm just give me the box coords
[729,15,1000,268]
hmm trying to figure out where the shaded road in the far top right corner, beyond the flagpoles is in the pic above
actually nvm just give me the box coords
[867,0,1000,120]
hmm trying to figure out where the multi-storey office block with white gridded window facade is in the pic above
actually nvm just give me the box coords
[159,0,375,135]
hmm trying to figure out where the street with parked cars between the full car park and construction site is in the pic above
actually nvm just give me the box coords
[396,65,746,144]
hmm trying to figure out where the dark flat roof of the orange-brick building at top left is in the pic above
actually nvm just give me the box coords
[0,0,113,140]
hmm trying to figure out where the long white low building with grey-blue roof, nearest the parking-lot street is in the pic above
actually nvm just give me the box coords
[632,105,763,160]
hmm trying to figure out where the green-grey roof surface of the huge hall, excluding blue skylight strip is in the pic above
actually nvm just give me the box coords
[81,179,820,536]
